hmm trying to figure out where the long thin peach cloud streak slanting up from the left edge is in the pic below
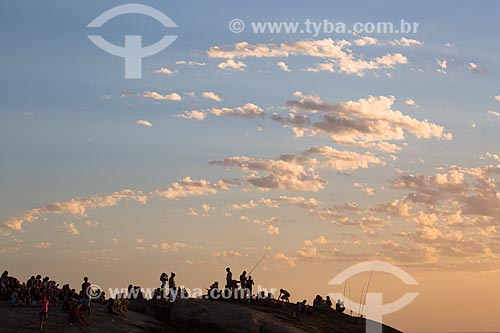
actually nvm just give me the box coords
[3,189,147,232]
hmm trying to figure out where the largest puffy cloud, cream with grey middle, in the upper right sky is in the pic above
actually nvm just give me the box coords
[271,92,452,152]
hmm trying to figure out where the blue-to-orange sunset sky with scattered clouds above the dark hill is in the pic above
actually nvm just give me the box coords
[0,0,500,332]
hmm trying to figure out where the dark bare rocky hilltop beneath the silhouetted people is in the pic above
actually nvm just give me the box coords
[0,299,400,333]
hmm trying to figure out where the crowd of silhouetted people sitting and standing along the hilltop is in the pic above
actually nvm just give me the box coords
[0,267,345,331]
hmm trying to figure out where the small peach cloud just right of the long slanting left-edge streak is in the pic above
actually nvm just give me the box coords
[156,177,233,200]
